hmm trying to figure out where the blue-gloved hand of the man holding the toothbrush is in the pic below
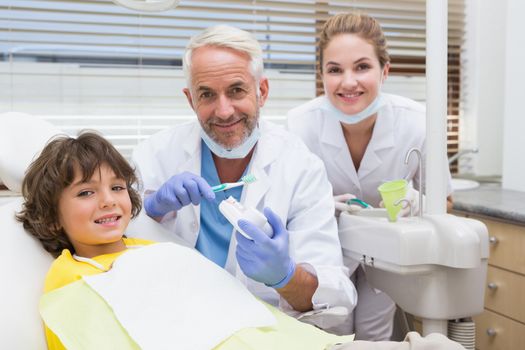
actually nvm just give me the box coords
[144,172,215,217]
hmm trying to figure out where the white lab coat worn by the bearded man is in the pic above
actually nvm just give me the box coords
[133,121,357,320]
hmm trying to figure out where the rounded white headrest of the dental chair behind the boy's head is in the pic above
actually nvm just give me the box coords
[0,112,61,192]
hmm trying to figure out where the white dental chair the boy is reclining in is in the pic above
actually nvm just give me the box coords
[0,112,175,350]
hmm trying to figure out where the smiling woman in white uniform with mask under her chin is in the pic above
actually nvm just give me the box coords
[288,13,451,340]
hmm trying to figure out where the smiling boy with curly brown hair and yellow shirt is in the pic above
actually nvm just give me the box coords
[17,133,151,349]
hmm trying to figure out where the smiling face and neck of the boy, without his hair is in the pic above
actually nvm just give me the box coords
[58,164,131,258]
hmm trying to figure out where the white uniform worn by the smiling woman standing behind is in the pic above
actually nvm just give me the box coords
[288,94,451,340]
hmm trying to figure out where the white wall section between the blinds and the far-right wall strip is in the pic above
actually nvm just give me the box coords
[460,0,508,176]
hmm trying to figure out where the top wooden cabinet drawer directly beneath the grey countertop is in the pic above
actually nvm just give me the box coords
[479,218,525,274]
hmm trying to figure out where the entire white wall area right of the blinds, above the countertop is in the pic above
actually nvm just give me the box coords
[466,0,525,192]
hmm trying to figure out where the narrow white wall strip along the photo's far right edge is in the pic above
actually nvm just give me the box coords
[503,0,525,192]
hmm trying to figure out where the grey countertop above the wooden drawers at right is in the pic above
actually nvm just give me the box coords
[452,183,525,225]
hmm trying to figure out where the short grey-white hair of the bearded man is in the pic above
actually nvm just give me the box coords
[182,25,264,87]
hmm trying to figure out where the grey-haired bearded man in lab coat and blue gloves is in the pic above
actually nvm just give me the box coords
[133,26,356,326]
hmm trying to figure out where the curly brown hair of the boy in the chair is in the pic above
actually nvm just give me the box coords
[16,132,142,257]
